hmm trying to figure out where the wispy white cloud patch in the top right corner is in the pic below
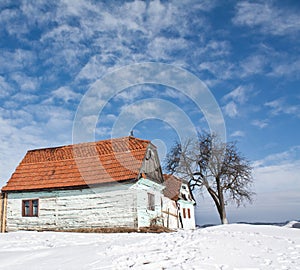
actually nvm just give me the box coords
[233,1,300,36]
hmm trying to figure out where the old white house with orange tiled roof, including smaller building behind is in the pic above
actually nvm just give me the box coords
[0,136,195,232]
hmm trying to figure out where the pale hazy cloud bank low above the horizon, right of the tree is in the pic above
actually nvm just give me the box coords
[228,146,300,222]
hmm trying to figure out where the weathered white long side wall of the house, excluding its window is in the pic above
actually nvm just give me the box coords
[6,184,138,231]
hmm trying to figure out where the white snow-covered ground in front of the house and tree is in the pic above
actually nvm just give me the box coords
[0,223,300,270]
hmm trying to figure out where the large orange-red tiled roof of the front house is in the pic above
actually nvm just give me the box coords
[2,137,150,191]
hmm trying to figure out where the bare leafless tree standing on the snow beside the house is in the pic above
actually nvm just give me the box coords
[165,133,254,224]
